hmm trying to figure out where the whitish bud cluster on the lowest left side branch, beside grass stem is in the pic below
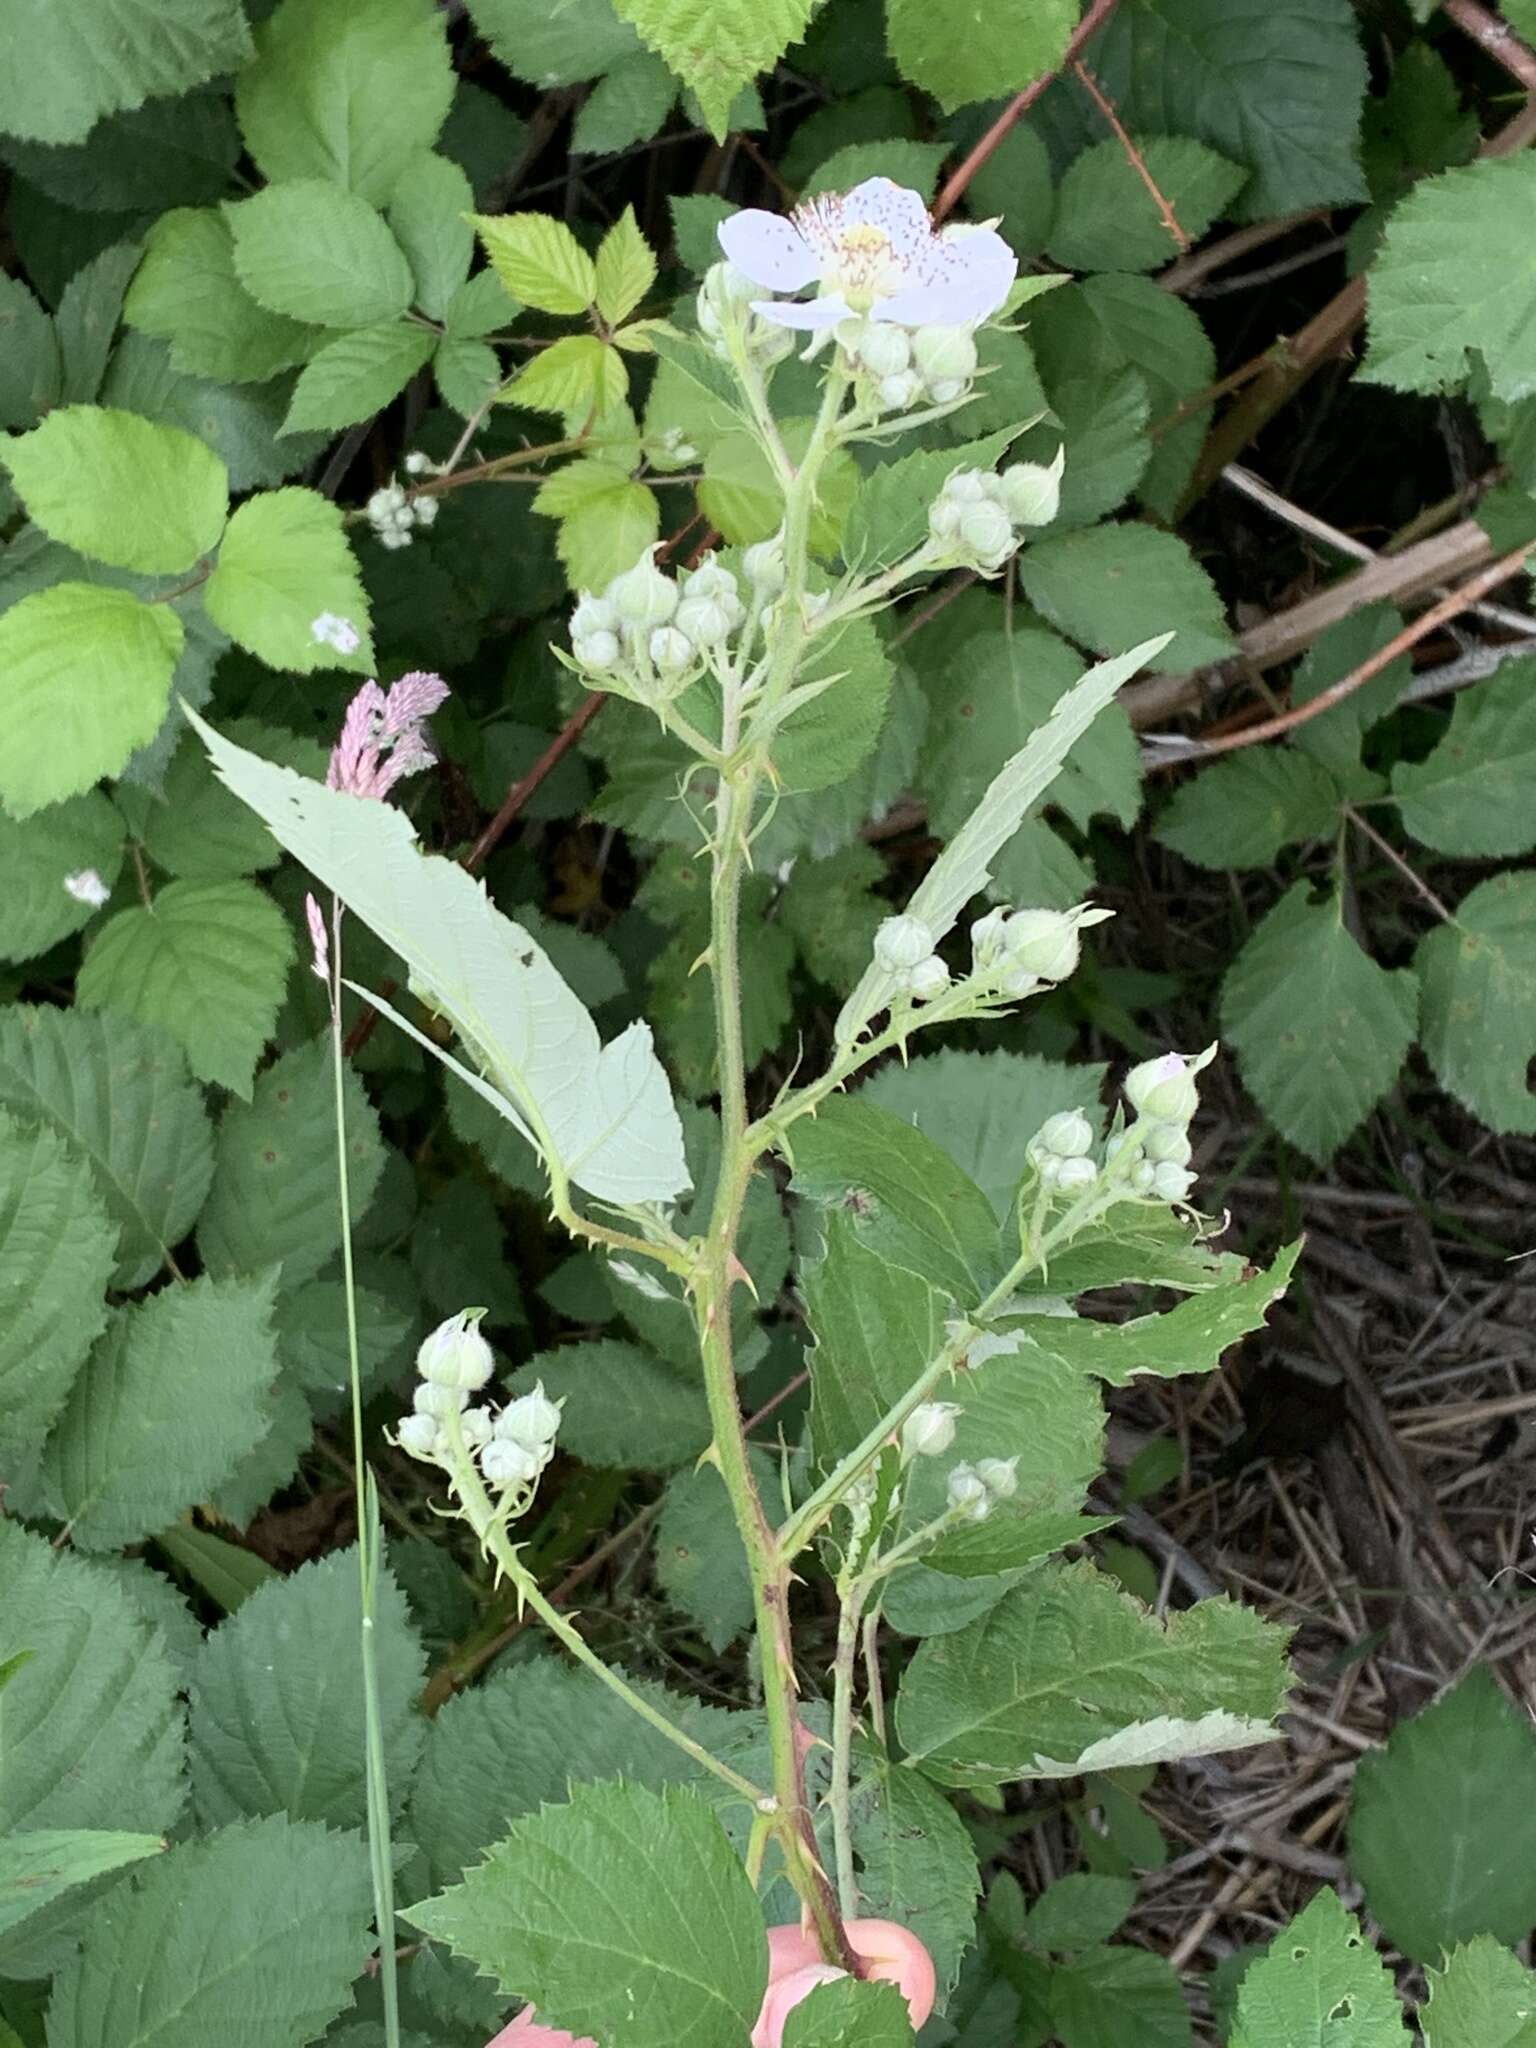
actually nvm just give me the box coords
[397,1309,561,1513]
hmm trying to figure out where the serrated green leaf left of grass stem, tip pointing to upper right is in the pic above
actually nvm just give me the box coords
[43,1274,276,1550]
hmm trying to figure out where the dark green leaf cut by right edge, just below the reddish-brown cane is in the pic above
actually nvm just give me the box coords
[1393,659,1536,856]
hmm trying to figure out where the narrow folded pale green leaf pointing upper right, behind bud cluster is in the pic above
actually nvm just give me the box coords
[836,635,1169,1044]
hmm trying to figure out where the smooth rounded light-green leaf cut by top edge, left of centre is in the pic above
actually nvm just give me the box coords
[236,0,453,207]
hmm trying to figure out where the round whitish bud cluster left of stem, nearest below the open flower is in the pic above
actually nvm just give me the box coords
[571,543,753,702]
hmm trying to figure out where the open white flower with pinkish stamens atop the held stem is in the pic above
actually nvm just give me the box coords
[719,178,1018,332]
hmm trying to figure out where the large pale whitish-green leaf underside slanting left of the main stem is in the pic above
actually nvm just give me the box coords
[188,717,688,1202]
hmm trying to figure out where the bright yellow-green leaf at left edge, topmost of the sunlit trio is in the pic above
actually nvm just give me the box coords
[4,406,229,575]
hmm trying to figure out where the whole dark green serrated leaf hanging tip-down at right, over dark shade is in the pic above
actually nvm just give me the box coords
[1221,881,1417,1161]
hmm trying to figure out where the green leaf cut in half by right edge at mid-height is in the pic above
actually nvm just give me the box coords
[1413,874,1536,1130]
